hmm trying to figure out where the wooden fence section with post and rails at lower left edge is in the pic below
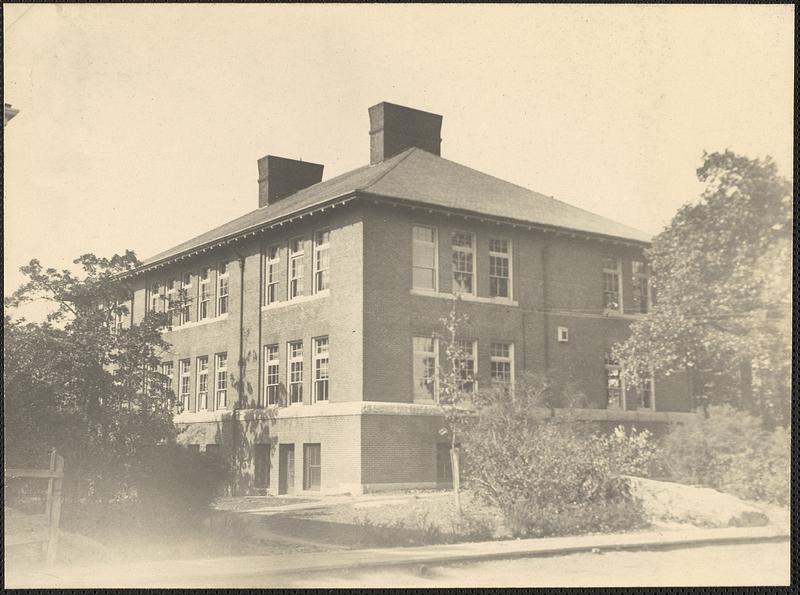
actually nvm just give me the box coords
[4,449,64,564]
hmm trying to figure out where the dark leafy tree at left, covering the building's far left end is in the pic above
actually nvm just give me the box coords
[3,252,174,500]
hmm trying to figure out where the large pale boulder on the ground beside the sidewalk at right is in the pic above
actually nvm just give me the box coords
[625,476,769,527]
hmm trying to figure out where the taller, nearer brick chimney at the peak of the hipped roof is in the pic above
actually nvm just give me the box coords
[369,101,442,165]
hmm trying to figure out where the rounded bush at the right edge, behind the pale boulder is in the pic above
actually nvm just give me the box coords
[663,405,791,505]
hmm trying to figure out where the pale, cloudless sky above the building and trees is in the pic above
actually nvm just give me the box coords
[3,4,794,310]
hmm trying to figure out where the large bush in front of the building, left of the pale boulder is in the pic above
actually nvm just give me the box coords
[462,379,647,536]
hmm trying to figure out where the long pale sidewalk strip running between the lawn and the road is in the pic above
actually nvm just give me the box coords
[5,527,789,588]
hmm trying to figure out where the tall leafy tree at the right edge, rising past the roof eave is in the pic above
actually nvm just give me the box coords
[615,151,792,422]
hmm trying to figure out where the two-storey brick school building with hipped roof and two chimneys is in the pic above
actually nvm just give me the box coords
[123,102,693,494]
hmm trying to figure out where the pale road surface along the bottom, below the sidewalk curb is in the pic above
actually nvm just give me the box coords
[274,542,789,588]
